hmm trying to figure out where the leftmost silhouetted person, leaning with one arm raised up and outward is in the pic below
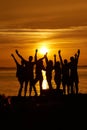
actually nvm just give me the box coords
[11,54,25,96]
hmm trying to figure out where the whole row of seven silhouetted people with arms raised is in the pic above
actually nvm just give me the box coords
[11,49,80,96]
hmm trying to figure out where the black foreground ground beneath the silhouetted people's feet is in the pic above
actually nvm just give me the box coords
[0,90,87,130]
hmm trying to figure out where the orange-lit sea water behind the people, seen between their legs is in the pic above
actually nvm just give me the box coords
[0,67,87,96]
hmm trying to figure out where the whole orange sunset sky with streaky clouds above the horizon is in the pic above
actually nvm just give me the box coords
[0,0,87,67]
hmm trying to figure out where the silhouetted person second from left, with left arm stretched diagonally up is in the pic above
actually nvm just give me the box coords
[16,50,37,96]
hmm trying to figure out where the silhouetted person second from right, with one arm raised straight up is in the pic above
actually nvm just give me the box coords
[58,50,70,94]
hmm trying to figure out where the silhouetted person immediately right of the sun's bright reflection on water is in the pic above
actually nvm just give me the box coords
[45,53,53,90]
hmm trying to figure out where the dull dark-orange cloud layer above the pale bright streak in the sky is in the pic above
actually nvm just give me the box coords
[0,0,87,29]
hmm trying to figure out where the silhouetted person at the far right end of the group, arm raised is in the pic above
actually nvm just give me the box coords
[69,49,80,94]
